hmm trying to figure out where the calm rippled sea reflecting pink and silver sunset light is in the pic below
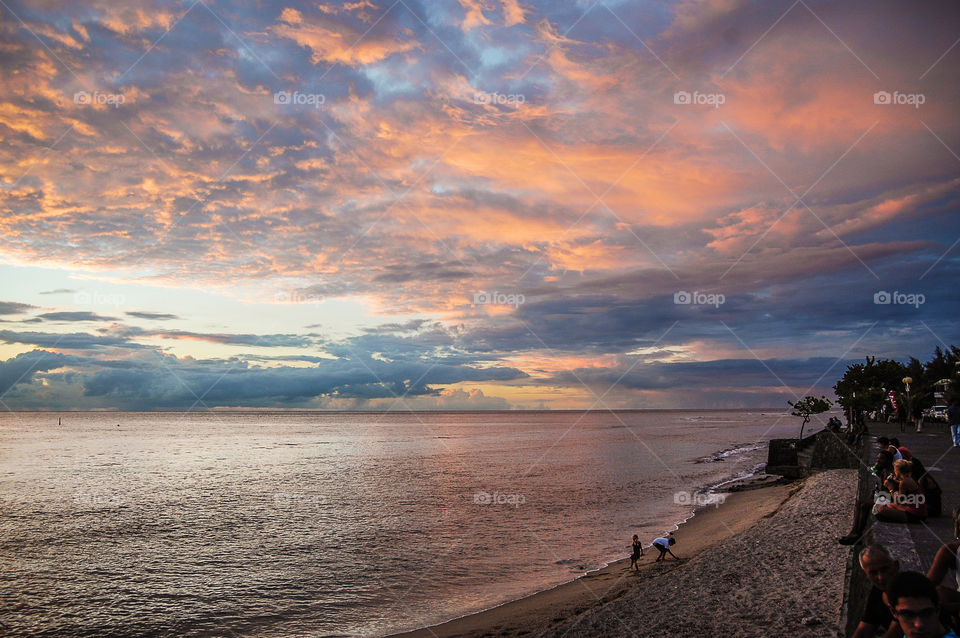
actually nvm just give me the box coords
[0,411,798,637]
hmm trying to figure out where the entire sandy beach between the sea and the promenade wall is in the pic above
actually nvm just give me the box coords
[386,470,856,638]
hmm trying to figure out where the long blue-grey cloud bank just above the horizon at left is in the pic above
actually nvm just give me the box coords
[0,331,526,409]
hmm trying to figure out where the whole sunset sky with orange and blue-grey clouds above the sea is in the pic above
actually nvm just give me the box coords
[0,0,960,410]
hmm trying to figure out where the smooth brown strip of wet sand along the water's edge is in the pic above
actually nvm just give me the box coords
[386,475,803,638]
